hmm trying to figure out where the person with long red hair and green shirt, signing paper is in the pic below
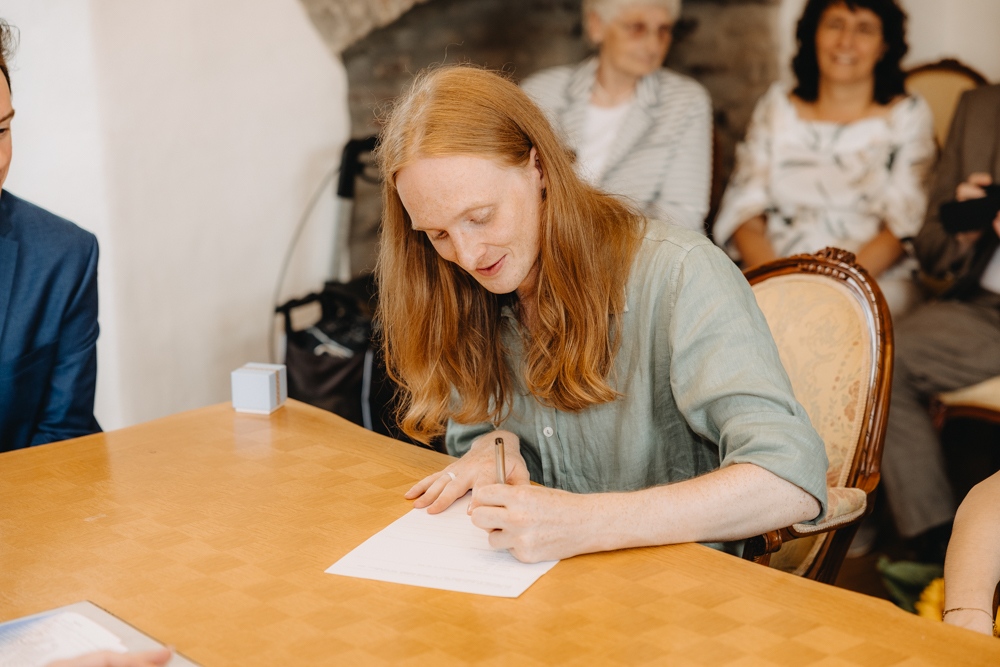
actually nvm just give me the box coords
[377,67,827,562]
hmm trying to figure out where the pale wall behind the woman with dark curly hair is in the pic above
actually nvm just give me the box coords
[778,0,1000,83]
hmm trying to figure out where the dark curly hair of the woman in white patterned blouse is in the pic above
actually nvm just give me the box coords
[792,0,909,104]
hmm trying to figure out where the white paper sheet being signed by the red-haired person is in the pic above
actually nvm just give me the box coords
[326,494,559,598]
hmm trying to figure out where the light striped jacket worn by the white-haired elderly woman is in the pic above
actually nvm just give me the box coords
[521,58,712,232]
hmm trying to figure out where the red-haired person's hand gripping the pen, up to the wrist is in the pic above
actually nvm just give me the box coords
[472,484,603,563]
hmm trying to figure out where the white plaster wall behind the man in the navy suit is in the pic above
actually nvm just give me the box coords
[0,0,349,428]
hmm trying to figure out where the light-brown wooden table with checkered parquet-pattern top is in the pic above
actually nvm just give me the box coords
[0,401,1000,667]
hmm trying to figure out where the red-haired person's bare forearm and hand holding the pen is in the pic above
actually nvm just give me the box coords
[460,464,820,563]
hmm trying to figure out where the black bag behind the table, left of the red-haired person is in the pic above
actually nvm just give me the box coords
[277,276,419,444]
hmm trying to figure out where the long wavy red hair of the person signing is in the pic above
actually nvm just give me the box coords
[376,66,645,442]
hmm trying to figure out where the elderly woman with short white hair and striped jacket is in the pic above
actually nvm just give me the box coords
[522,0,712,232]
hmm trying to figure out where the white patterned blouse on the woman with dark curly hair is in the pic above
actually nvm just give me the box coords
[714,83,937,277]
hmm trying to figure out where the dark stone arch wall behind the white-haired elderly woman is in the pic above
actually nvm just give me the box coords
[301,0,781,270]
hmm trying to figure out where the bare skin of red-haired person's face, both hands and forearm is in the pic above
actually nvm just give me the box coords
[396,151,820,562]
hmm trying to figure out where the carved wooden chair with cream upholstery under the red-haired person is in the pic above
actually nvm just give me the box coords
[743,248,892,583]
